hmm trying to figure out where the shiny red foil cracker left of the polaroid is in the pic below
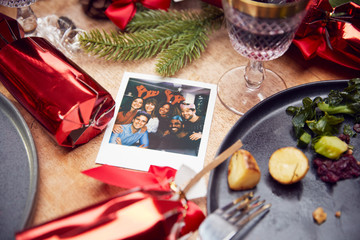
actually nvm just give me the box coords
[0,15,115,147]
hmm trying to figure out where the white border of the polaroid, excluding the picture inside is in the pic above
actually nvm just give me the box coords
[96,72,216,172]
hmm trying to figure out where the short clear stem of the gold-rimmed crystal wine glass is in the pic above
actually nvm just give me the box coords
[244,59,265,90]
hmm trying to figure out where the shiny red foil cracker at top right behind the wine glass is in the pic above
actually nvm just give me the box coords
[293,0,360,70]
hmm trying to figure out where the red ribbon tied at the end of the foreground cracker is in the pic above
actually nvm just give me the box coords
[83,165,205,235]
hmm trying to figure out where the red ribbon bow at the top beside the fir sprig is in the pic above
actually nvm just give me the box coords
[105,0,171,30]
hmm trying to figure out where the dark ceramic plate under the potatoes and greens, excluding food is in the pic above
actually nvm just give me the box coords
[207,80,360,240]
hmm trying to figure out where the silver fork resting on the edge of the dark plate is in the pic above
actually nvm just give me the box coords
[199,192,271,240]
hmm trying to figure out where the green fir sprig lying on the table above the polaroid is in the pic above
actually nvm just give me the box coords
[79,5,224,76]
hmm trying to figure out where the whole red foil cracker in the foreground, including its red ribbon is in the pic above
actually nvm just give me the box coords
[16,165,205,240]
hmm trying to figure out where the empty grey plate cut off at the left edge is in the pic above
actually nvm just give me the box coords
[0,94,38,240]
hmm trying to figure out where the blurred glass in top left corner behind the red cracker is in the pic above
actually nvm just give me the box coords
[0,0,37,34]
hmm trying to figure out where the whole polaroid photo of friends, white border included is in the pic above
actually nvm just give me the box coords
[96,72,216,172]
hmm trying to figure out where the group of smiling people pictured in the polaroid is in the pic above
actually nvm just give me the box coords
[109,94,205,156]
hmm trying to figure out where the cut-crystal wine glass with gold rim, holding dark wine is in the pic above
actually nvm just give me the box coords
[218,0,309,115]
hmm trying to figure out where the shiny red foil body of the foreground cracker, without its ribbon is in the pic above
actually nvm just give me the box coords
[16,189,183,240]
